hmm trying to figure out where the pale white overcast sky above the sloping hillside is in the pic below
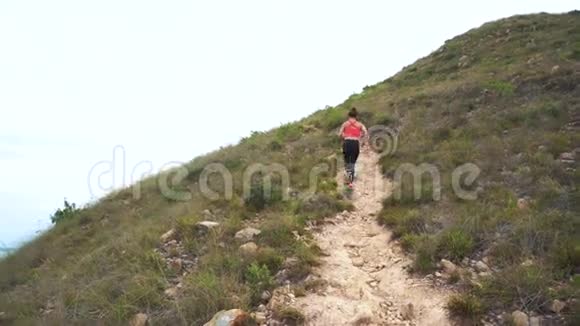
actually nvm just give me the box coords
[0,0,578,244]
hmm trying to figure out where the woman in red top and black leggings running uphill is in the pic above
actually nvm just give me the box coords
[339,108,368,188]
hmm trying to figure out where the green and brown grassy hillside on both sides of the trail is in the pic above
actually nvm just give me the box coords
[0,12,580,325]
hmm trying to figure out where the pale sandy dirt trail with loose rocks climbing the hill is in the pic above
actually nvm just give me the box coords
[292,151,451,326]
